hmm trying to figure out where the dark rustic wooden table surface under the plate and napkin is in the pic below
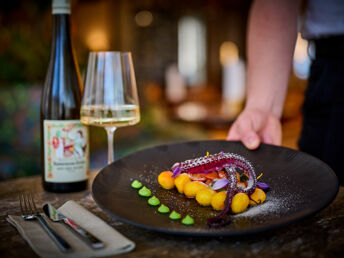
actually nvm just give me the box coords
[0,172,344,258]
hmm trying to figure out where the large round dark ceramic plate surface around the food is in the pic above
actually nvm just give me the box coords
[92,141,338,236]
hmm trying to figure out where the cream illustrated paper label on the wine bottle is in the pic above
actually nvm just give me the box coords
[43,120,89,183]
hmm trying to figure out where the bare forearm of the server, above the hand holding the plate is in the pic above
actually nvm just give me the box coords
[246,0,300,118]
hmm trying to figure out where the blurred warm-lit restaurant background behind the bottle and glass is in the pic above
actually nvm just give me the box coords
[0,0,310,180]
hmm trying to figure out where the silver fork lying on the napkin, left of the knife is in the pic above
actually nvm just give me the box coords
[19,192,71,252]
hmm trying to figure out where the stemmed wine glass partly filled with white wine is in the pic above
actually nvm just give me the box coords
[80,51,140,164]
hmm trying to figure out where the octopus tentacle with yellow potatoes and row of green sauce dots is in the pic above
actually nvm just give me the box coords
[131,152,269,227]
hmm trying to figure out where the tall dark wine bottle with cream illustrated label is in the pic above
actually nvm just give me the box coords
[40,0,89,192]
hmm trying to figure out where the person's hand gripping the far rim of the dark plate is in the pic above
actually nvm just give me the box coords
[227,109,282,150]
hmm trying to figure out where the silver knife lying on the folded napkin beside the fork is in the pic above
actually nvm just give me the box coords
[43,203,104,249]
